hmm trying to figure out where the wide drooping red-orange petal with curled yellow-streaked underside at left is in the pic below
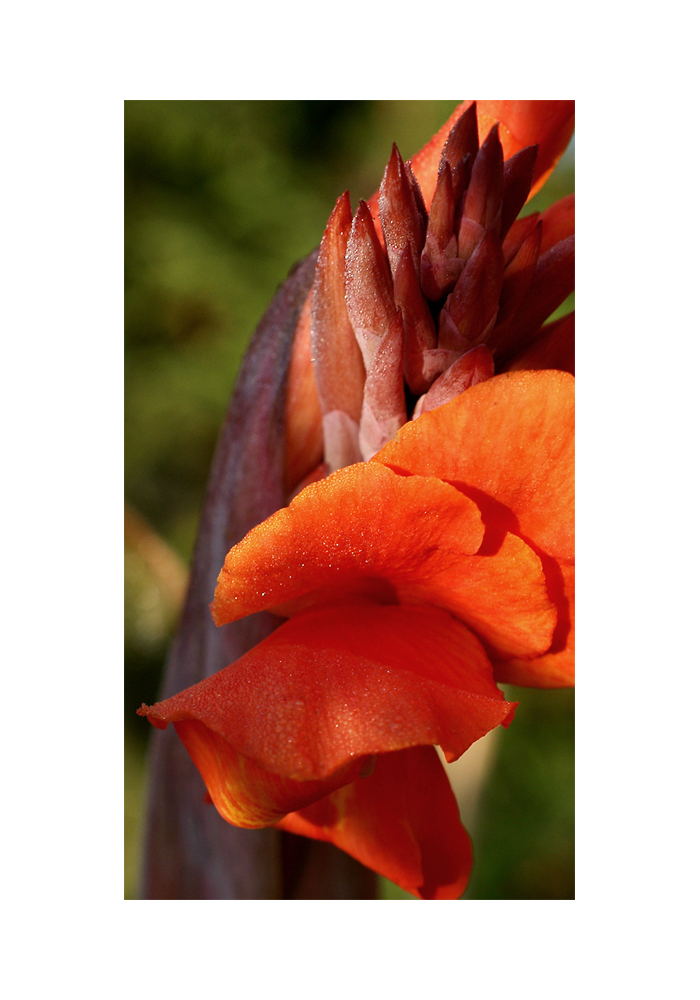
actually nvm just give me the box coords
[140,604,514,827]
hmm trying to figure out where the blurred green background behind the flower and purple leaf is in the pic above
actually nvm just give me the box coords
[125,100,574,899]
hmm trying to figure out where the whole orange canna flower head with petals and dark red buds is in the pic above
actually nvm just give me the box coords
[140,101,574,899]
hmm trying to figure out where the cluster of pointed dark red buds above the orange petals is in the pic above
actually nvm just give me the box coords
[311,103,574,472]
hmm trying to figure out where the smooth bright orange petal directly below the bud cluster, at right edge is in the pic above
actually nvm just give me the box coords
[378,371,574,560]
